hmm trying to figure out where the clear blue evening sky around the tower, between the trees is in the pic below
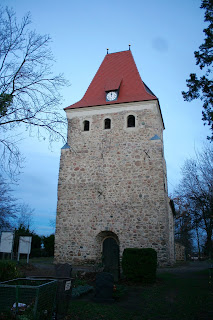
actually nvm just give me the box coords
[0,0,210,235]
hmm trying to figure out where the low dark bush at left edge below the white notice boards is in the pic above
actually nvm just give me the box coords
[0,260,21,282]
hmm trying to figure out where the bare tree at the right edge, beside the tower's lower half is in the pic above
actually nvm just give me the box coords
[176,145,213,256]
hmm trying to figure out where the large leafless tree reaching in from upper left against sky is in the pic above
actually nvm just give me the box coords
[0,8,68,178]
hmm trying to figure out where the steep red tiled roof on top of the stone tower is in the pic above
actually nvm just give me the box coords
[65,50,157,110]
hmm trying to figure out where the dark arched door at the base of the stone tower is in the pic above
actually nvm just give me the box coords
[102,237,120,281]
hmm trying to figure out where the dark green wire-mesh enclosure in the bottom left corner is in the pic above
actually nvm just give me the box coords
[0,278,57,320]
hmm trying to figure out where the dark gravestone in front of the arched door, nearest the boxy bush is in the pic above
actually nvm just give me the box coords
[94,272,114,302]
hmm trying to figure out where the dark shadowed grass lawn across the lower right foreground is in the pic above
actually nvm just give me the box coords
[66,270,213,320]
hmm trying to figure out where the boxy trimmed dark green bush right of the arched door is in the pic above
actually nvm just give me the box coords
[122,248,157,283]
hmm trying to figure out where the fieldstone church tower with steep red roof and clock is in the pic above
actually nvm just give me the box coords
[55,50,174,271]
